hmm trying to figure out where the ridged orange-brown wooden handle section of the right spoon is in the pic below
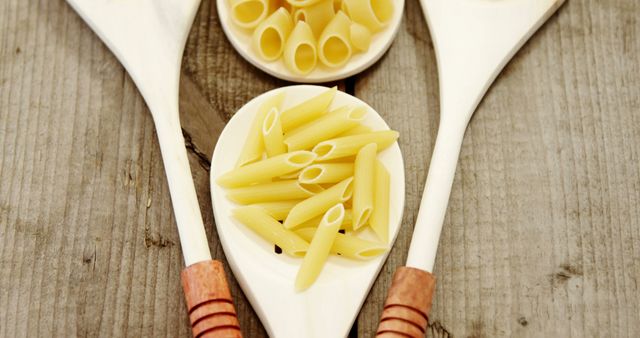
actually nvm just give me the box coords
[376,267,436,338]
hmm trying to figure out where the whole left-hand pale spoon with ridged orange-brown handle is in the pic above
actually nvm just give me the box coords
[67,0,241,337]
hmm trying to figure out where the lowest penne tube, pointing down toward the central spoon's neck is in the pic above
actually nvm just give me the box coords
[295,203,344,291]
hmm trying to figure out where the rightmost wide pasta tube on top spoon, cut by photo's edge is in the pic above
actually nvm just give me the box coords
[344,0,394,32]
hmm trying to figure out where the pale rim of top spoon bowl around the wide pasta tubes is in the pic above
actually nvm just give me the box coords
[217,0,405,83]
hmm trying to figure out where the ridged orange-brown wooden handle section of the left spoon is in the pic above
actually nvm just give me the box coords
[181,260,242,338]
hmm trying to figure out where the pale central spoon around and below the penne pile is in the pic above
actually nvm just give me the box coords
[211,85,404,338]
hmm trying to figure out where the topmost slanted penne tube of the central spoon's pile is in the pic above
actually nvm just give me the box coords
[280,87,338,133]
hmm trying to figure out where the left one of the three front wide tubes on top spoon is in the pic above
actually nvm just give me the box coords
[251,7,293,61]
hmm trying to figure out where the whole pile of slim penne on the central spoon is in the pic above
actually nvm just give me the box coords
[216,87,398,290]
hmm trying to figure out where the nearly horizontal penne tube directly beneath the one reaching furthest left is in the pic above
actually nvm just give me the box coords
[227,180,324,204]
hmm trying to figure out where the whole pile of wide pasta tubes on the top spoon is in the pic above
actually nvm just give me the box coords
[229,0,394,75]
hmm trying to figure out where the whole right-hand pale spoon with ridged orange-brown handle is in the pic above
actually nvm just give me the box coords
[378,0,564,337]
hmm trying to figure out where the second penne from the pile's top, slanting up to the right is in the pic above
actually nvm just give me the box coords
[284,106,367,151]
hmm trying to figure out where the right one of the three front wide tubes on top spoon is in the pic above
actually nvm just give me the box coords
[318,11,352,68]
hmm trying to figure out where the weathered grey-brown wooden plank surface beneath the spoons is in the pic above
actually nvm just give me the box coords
[0,0,640,337]
